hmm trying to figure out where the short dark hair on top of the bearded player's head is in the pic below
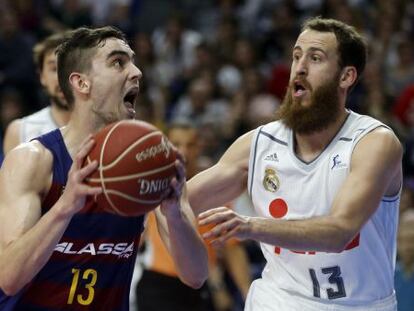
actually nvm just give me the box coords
[302,17,367,78]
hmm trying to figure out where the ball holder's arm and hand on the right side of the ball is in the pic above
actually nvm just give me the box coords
[155,162,208,288]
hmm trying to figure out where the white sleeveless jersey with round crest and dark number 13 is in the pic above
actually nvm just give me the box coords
[246,111,399,311]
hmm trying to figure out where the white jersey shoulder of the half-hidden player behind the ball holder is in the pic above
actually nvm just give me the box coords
[20,106,58,143]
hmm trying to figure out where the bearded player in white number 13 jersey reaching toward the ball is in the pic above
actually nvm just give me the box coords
[189,18,402,311]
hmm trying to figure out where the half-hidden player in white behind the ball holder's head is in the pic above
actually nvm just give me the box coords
[3,32,70,154]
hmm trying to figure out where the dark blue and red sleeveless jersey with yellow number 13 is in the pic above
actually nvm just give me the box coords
[0,130,144,311]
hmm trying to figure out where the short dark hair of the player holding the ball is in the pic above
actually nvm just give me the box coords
[57,26,127,107]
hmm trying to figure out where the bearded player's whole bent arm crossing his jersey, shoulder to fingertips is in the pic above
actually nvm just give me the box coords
[200,128,402,252]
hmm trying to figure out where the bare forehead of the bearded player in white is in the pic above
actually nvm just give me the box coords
[293,29,338,54]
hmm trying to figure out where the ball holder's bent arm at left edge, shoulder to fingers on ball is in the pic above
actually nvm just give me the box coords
[0,138,101,295]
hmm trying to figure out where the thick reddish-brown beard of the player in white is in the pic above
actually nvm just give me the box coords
[276,73,341,134]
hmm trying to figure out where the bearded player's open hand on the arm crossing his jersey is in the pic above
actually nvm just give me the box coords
[198,207,251,245]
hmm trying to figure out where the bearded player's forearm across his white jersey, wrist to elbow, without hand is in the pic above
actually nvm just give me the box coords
[248,216,357,252]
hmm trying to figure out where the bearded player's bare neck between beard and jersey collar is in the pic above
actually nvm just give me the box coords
[295,109,348,162]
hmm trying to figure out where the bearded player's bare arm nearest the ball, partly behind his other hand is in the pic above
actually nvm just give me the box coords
[187,132,253,216]
